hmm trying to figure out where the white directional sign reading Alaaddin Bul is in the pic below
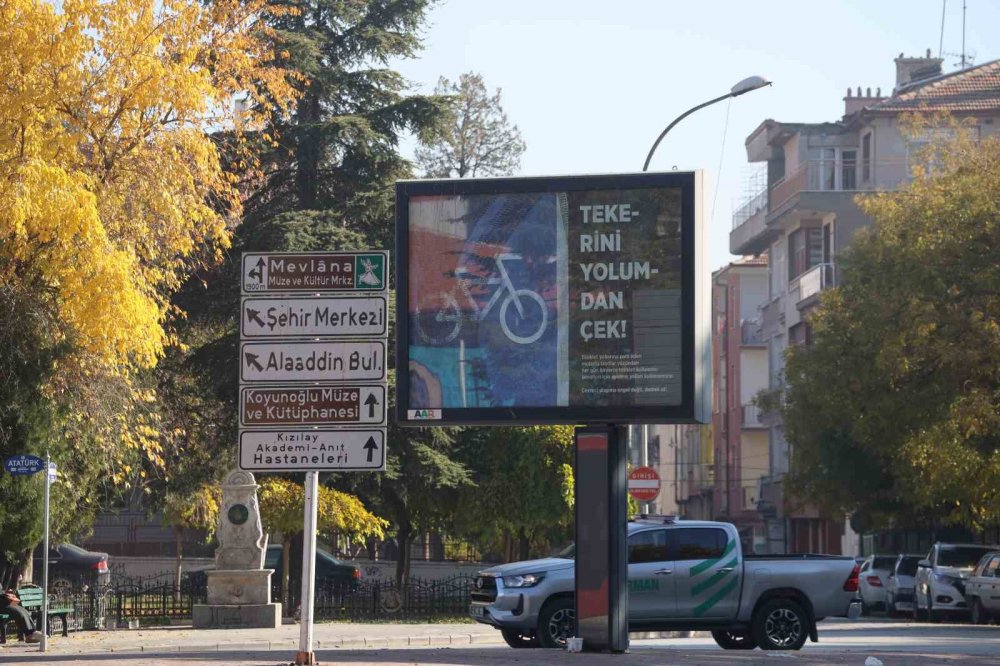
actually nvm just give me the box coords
[240,340,386,383]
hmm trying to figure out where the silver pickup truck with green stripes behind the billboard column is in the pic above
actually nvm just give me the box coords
[469,517,861,650]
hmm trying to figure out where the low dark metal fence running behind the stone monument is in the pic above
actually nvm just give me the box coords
[37,574,474,631]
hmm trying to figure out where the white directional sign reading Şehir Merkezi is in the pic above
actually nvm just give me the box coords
[240,295,388,339]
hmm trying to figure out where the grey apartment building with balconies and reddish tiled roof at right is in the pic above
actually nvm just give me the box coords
[717,51,1000,553]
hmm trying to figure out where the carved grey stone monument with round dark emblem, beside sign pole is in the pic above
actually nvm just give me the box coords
[193,470,281,629]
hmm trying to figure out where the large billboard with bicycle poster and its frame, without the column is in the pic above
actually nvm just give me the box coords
[396,172,710,425]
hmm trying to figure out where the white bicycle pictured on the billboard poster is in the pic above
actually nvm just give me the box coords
[416,254,549,345]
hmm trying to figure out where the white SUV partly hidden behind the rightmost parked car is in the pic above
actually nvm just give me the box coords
[913,543,1000,622]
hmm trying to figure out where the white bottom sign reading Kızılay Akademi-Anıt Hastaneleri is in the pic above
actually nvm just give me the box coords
[239,428,385,472]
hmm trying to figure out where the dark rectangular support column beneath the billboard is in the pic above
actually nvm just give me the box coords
[574,425,628,652]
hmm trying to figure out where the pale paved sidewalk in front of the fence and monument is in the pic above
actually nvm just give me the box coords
[0,622,503,661]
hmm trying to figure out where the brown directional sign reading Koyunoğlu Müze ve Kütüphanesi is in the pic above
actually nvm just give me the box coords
[240,384,386,427]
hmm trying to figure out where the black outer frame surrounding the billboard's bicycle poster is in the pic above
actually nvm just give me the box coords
[395,171,711,427]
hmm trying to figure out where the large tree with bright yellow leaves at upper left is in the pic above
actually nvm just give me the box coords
[0,0,295,580]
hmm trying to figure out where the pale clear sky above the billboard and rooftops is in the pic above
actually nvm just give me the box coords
[391,0,1000,270]
